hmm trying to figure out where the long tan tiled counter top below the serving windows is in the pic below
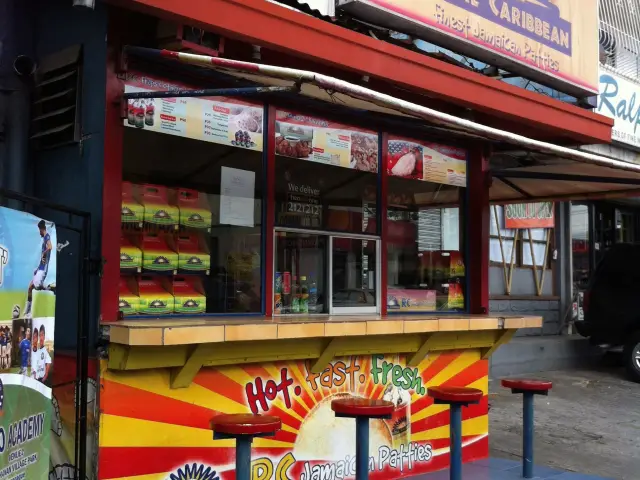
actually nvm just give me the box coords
[103,315,542,346]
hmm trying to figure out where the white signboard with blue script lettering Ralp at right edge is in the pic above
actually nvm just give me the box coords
[597,69,640,147]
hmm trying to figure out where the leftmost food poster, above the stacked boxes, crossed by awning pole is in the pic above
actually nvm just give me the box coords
[124,73,264,152]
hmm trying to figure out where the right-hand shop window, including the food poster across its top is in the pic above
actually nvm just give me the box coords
[386,138,466,312]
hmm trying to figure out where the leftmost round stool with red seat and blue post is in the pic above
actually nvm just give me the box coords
[211,413,282,480]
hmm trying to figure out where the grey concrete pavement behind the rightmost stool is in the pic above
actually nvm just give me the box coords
[489,367,640,480]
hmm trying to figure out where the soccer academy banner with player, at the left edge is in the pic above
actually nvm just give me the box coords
[0,207,57,480]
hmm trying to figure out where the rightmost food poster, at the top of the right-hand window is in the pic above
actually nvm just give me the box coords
[387,137,467,187]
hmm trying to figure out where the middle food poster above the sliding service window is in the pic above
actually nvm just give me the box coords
[276,110,378,172]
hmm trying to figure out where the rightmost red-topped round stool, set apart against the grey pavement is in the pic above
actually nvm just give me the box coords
[501,378,553,478]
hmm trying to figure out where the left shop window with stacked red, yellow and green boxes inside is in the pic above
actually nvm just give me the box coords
[120,76,264,316]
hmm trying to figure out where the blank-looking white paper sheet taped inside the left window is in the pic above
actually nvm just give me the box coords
[220,167,256,227]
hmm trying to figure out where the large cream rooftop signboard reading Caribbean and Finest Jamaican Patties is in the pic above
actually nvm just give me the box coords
[338,0,599,96]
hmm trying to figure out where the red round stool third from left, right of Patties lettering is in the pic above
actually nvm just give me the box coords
[427,387,483,480]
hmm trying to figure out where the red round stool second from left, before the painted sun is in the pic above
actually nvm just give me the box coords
[331,397,395,480]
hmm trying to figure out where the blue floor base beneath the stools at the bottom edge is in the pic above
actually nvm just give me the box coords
[412,458,613,480]
